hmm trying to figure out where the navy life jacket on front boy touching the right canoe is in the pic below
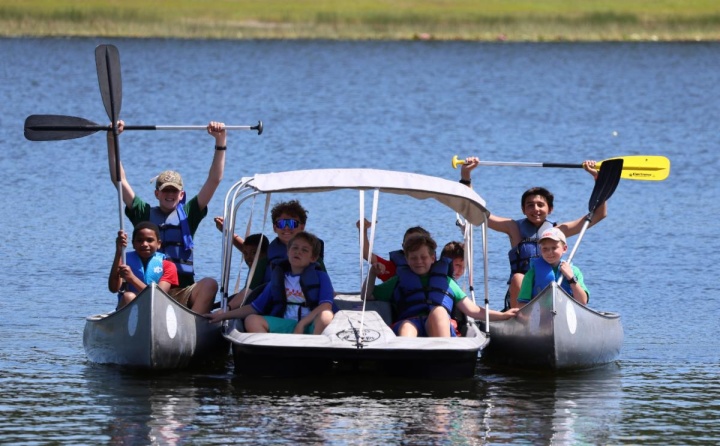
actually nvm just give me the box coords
[393,257,454,320]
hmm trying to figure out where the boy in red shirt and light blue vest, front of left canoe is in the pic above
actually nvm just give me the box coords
[108,221,178,310]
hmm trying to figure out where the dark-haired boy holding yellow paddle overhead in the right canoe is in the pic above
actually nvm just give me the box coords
[460,157,607,308]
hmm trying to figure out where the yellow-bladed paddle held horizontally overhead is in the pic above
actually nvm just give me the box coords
[452,155,670,181]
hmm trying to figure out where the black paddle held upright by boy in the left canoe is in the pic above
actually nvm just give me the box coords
[95,45,125,264]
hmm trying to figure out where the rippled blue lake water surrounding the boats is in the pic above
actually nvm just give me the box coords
[0,39,720,444]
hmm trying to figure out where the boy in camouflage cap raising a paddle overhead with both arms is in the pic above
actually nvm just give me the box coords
[107,121,227,314]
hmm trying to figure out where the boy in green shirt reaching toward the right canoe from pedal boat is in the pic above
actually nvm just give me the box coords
[373,235,517,337]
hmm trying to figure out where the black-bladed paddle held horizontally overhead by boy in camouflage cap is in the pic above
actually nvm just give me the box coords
[25,115,263,141]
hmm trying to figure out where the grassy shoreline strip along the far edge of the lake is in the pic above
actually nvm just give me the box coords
[0,0,720,41]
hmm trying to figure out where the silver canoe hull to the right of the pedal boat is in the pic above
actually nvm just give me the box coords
[483,283,623,370]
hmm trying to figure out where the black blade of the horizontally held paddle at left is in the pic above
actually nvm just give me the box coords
[25,115,109,141]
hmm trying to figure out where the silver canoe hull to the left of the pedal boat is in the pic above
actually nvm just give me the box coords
[83,284,229,370]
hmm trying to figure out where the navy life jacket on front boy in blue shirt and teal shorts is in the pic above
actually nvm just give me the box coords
[261,260,322,320]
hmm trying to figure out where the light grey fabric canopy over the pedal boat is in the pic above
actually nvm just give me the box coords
[236,169,490,226]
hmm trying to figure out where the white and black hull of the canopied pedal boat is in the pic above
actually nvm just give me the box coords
[225,298,488,379]
